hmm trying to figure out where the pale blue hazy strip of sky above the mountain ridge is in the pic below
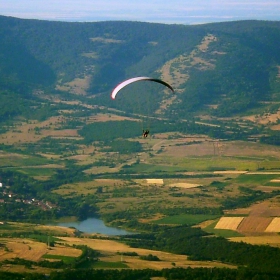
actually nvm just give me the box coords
[0,0,280,24]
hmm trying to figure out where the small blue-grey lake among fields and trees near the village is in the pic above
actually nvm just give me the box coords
[52,218,135,235]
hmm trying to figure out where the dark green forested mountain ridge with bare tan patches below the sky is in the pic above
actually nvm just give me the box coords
[0,16,280,120]
